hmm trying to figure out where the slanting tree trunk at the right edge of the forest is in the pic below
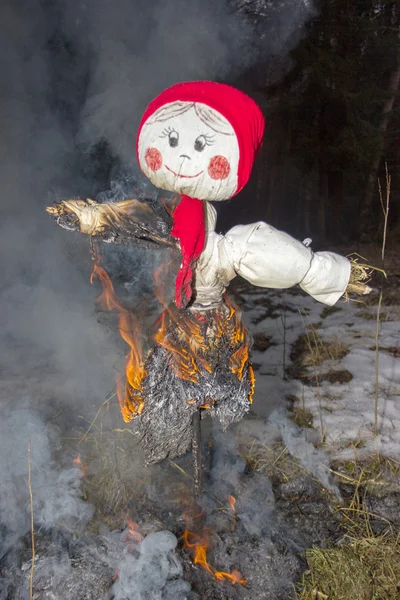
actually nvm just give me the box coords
[360,43,400,233]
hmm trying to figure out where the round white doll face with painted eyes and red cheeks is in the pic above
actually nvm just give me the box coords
[138,102,239,200]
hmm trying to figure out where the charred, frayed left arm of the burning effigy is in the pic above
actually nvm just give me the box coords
[46,199,178,249]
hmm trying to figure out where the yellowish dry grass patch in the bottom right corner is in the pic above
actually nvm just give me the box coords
[297,456,400,600]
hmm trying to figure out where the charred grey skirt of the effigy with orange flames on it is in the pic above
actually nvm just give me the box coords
[125,298,254,462]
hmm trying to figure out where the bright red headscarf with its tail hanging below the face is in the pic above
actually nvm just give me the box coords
[136,81,265,308]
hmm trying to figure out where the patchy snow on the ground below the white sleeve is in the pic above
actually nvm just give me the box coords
[237,285,400,460]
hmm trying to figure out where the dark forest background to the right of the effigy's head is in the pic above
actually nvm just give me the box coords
[228,0,400,244]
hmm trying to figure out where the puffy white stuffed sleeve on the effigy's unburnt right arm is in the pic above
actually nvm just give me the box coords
[220,222,350,305]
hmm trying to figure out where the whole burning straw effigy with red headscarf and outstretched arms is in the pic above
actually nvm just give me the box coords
[47,81,369,462]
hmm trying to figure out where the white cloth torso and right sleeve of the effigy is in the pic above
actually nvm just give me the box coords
[193,203,351,309]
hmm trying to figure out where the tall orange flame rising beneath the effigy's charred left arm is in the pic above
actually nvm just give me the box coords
[90,257,146,423]
